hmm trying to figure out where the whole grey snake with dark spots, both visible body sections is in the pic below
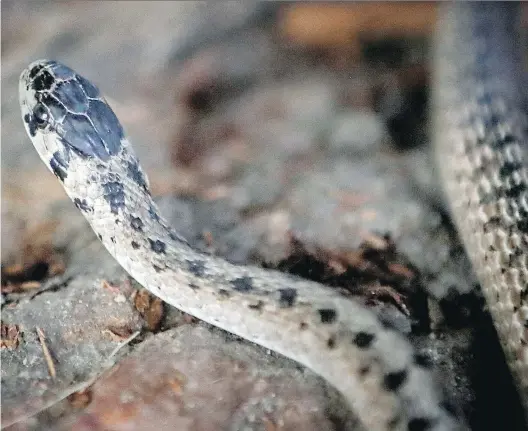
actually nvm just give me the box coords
[19,2,528,431]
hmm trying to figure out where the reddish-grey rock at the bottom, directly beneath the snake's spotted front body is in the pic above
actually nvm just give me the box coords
[64,325,352,431]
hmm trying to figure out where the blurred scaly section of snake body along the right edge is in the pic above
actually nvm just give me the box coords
[432,2,528,420]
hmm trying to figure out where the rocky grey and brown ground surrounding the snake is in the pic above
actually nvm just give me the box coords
[1,0,526,431]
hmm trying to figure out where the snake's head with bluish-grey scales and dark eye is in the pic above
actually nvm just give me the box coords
[19,60,124,165]
